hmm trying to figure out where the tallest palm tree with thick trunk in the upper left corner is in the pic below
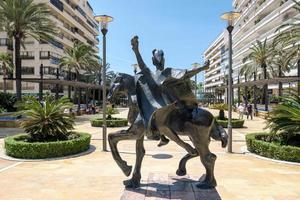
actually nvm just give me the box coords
[0,0,56,100]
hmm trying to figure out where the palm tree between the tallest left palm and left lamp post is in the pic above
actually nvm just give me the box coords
[59,41,99,113]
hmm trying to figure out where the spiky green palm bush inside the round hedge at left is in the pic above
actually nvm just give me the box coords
[20,96,74,142]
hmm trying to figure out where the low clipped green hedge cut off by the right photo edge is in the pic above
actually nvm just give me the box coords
[246,133,300,163]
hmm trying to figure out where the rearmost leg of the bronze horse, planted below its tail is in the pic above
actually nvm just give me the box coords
[191,126,217,189]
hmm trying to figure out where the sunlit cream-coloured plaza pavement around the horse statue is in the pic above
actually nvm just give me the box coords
[0,110,300,200]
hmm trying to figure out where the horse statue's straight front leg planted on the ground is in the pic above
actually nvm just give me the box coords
[124,136,145,188]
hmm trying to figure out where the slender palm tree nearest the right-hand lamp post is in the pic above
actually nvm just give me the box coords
[246,38,272,111]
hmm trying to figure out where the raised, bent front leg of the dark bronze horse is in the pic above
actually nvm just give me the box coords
[108,124,144,176]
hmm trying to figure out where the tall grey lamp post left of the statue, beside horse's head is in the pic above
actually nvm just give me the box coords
[95,15,113,151]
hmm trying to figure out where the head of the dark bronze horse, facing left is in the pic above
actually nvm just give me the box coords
[107,73,135,101]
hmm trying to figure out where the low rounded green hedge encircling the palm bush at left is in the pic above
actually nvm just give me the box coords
[4,133,91,159]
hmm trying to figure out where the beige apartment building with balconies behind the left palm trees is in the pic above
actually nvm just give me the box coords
[0,0,99,94]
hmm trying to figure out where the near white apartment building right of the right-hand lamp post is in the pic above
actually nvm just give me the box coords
[233,0,300,89]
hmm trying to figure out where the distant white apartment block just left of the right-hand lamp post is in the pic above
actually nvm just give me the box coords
[204,31,228,101]
